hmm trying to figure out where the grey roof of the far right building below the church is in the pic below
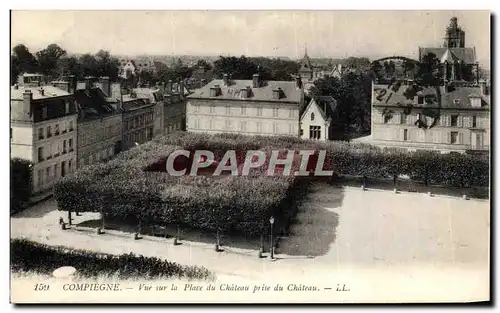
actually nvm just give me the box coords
[373,85,490,109]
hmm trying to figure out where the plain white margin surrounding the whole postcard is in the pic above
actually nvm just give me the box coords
[0,0,500,312]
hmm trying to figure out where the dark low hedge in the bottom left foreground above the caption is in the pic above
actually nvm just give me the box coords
[10,239,214,280]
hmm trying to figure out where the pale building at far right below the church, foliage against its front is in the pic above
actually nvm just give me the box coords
[371,84,490,152]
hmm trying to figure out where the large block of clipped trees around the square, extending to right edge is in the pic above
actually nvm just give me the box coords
[54,132,489,236]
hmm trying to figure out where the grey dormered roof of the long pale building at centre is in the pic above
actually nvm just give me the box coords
[188,79,302,103]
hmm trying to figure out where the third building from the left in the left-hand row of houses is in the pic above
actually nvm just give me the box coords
[121,93,155,150]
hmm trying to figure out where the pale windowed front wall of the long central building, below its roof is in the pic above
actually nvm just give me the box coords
[186,99,299,136]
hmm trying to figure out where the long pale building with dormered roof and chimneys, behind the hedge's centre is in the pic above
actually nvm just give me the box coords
[187,74,304,136]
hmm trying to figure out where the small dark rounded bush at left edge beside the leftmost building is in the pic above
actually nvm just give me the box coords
[10,158,33,214]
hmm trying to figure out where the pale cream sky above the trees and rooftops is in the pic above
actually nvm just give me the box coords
[11,11,490,68]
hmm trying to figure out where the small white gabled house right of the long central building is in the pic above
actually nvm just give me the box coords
[300,96,337,141]
